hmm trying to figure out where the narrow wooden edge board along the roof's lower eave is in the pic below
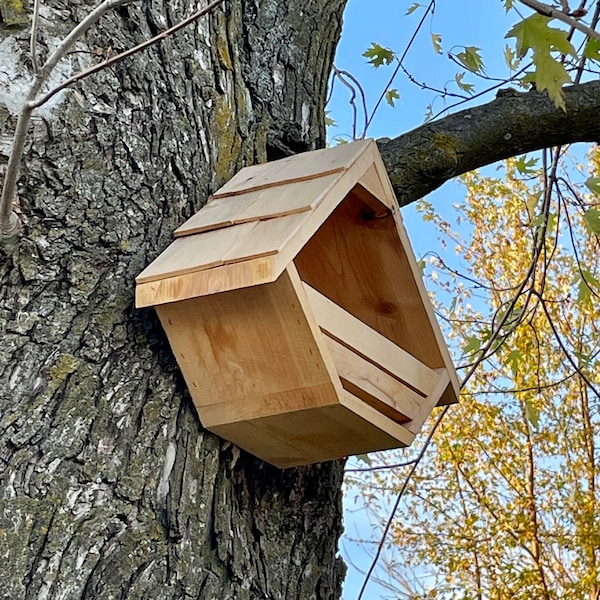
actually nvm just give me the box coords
[135,256,275,308]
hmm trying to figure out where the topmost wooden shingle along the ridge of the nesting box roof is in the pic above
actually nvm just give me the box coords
[214,140,374,198]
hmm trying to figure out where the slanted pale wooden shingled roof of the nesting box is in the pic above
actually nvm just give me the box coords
[136,140,395,307]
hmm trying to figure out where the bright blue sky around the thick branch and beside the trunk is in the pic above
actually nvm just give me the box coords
[328,0,527,600]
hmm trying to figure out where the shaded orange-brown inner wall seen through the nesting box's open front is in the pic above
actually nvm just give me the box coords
[294,193,446,369]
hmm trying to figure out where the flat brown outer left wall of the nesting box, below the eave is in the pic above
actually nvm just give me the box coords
[157,274,337,414]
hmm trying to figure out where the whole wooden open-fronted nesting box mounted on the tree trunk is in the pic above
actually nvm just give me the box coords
[136,141,458,467]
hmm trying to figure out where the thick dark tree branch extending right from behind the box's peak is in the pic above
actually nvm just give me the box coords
[378,81,600,206]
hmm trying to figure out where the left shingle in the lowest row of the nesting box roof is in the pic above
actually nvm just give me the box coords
[136,223,256,284]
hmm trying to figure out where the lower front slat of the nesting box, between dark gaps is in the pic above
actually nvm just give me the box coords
[325,336,425,423]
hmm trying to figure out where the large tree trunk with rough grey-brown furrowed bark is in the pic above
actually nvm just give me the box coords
[0,0,345,600]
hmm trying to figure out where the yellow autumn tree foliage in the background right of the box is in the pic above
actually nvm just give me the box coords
[352,151,600,600]
